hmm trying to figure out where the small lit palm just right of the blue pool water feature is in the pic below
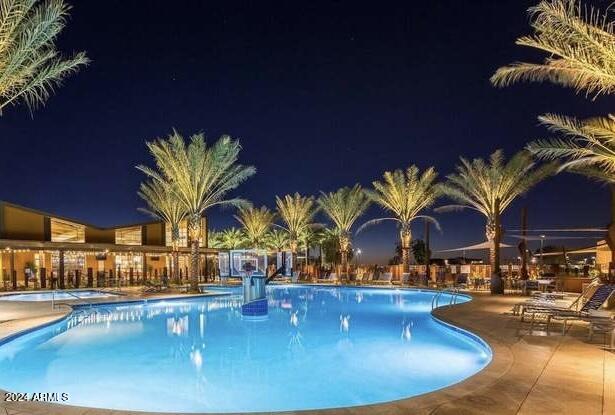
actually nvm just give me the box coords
[275,193,316,271]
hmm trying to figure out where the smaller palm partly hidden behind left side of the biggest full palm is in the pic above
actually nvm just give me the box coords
[138,181,187,281]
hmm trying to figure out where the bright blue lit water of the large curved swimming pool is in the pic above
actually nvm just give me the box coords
[0,286,491,412]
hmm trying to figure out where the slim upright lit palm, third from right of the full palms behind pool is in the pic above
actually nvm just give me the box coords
[318,184,371,275]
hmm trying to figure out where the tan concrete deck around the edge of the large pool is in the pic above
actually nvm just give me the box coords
[0,293,615,415]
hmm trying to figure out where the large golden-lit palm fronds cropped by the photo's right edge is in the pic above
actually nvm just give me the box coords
[491,0,615,262]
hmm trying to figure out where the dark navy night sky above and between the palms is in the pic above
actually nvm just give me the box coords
[0,0,614,261]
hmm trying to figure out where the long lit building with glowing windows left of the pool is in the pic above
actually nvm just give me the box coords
[0,201,217,289]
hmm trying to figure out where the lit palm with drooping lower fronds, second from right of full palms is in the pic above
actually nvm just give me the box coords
[357,165,441,272]
